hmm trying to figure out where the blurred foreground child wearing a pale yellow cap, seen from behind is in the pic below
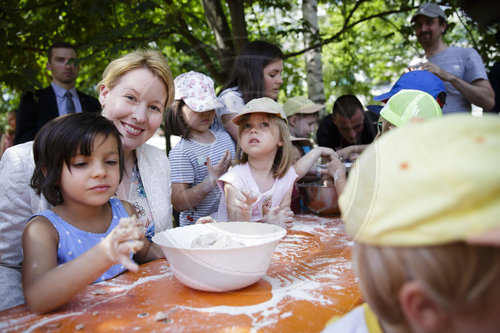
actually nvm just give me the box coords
[324,114,500,333]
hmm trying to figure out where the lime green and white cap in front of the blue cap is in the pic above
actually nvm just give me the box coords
[380,89,442,127]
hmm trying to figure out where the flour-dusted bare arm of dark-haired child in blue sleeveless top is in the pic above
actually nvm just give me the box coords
[23,216,142,313]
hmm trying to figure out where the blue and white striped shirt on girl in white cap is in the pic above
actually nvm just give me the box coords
[168,131,235,226]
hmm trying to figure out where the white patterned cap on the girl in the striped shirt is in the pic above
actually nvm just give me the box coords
[174,71,224,112]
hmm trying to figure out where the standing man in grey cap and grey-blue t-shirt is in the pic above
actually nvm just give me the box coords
[411,3,495,114]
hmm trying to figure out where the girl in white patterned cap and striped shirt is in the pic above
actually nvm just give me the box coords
[166,71,235,226]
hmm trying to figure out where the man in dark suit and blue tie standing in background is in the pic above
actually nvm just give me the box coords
[14,42,101,144]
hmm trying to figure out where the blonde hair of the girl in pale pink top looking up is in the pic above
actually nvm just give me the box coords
[235,112,294,178]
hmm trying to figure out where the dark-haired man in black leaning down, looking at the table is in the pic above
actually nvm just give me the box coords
[316,95,378,157]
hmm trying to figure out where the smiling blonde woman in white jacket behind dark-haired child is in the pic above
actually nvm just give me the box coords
[0,50,174,310]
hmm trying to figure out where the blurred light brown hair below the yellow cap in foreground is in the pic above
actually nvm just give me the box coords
[353,242,500,332]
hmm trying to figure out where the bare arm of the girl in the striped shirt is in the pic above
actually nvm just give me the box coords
[172,150,231,212]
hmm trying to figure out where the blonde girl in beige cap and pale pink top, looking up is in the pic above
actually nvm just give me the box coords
[217,97,335,227]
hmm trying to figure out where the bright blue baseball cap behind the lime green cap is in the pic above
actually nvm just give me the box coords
[373,71,446,101]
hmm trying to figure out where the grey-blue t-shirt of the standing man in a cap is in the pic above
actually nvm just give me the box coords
[428,46,488,114]
